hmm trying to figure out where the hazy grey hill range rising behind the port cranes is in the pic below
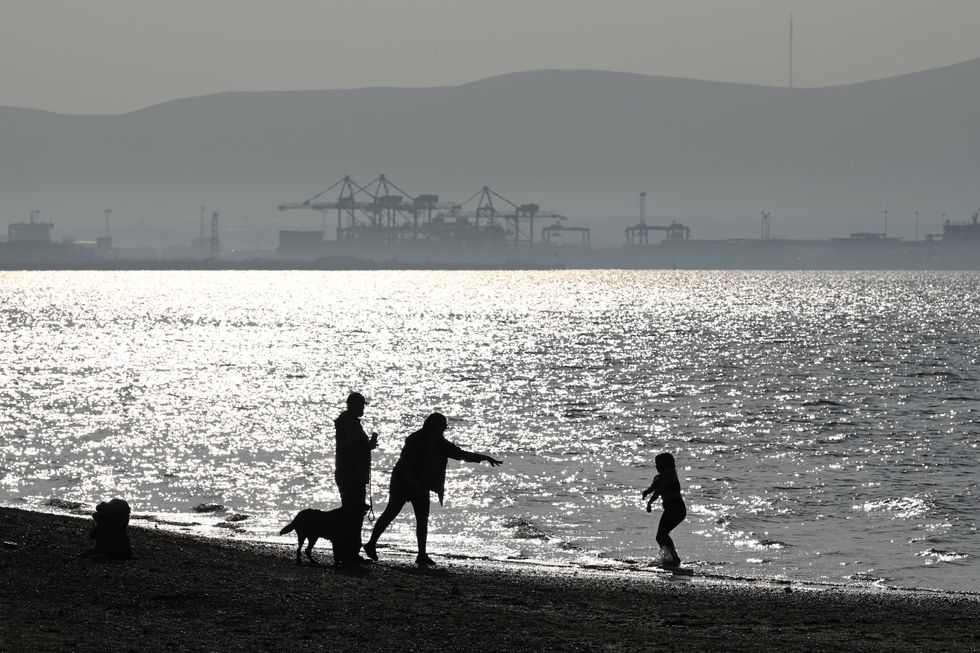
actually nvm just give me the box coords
[0,60,980,247]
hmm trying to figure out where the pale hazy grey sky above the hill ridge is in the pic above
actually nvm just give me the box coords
[0,0,980,113]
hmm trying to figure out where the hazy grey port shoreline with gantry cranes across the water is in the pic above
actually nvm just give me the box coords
[0,175,980,269]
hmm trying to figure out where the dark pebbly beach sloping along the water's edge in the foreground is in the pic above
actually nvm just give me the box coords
[0,509,980,653]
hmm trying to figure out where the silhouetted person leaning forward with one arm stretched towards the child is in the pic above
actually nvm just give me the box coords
[364,413,501,565]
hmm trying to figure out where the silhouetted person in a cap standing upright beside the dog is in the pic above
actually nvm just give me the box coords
[334,392,378,562]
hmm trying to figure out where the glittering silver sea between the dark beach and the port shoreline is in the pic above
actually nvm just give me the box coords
[0,271,980,592]
